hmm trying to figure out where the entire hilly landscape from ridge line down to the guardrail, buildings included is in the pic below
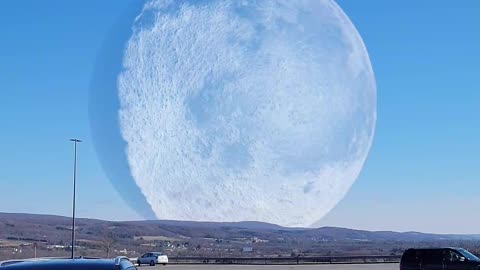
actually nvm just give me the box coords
[0,213,480,259]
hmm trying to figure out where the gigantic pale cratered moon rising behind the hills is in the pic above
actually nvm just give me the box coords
[91,0,376,227]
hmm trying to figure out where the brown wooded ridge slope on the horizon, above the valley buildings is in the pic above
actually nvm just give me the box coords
[0,212,480,242]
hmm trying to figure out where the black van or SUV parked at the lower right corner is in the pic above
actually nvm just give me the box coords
[400,248,480,270]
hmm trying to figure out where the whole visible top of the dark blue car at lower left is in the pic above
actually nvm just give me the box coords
[0,257,136,270]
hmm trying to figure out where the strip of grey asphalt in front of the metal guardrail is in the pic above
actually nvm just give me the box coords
[139,263,399,270]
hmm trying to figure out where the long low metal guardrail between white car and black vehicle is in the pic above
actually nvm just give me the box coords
[169,255,401,265]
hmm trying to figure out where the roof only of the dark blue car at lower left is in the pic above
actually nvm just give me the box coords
[0,259,115,270]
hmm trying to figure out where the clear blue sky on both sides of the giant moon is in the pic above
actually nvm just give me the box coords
[0,0,480,233]
